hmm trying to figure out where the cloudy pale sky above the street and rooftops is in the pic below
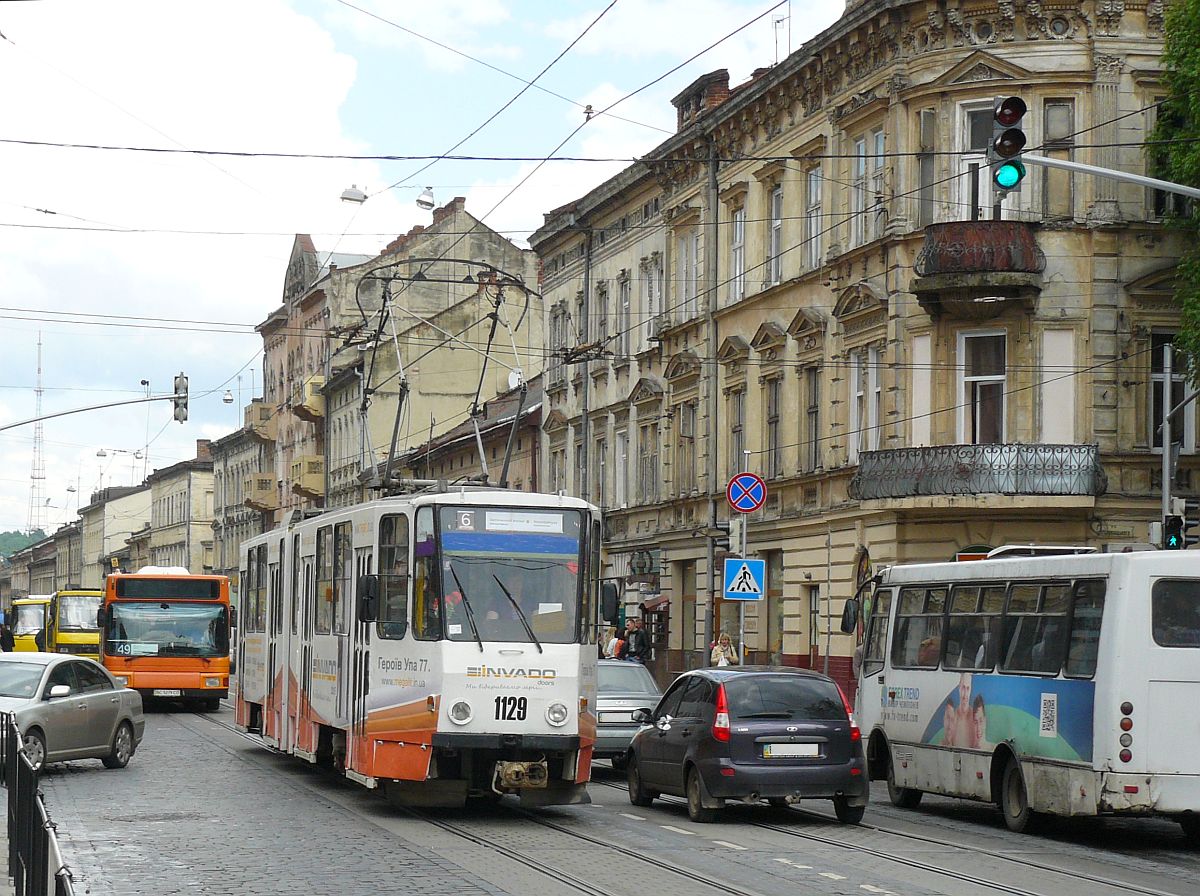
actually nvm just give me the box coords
[0,0,842,531]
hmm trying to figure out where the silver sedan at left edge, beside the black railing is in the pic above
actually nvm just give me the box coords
[0,653,145,771]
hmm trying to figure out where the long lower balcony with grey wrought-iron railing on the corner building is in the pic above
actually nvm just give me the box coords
[850,445,1108,501]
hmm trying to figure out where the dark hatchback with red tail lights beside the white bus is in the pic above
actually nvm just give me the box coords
[628,666,869,824]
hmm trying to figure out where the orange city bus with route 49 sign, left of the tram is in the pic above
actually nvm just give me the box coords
[97,566,233,711]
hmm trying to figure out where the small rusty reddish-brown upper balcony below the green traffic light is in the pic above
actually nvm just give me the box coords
[910,221,1046,320]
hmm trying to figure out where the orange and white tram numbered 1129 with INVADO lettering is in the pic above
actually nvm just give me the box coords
[236,488,600,806]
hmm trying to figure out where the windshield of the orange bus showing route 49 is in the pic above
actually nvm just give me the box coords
[104,602,229,656]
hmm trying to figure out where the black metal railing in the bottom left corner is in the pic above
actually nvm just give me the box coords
[0,712,74,896]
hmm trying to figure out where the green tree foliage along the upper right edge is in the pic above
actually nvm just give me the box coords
[1148,0,1200,374]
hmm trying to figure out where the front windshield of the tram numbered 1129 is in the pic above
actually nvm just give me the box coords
[438,506,586,644]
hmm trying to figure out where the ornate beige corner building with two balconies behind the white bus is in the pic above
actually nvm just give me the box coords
[530,0,1180,678]
